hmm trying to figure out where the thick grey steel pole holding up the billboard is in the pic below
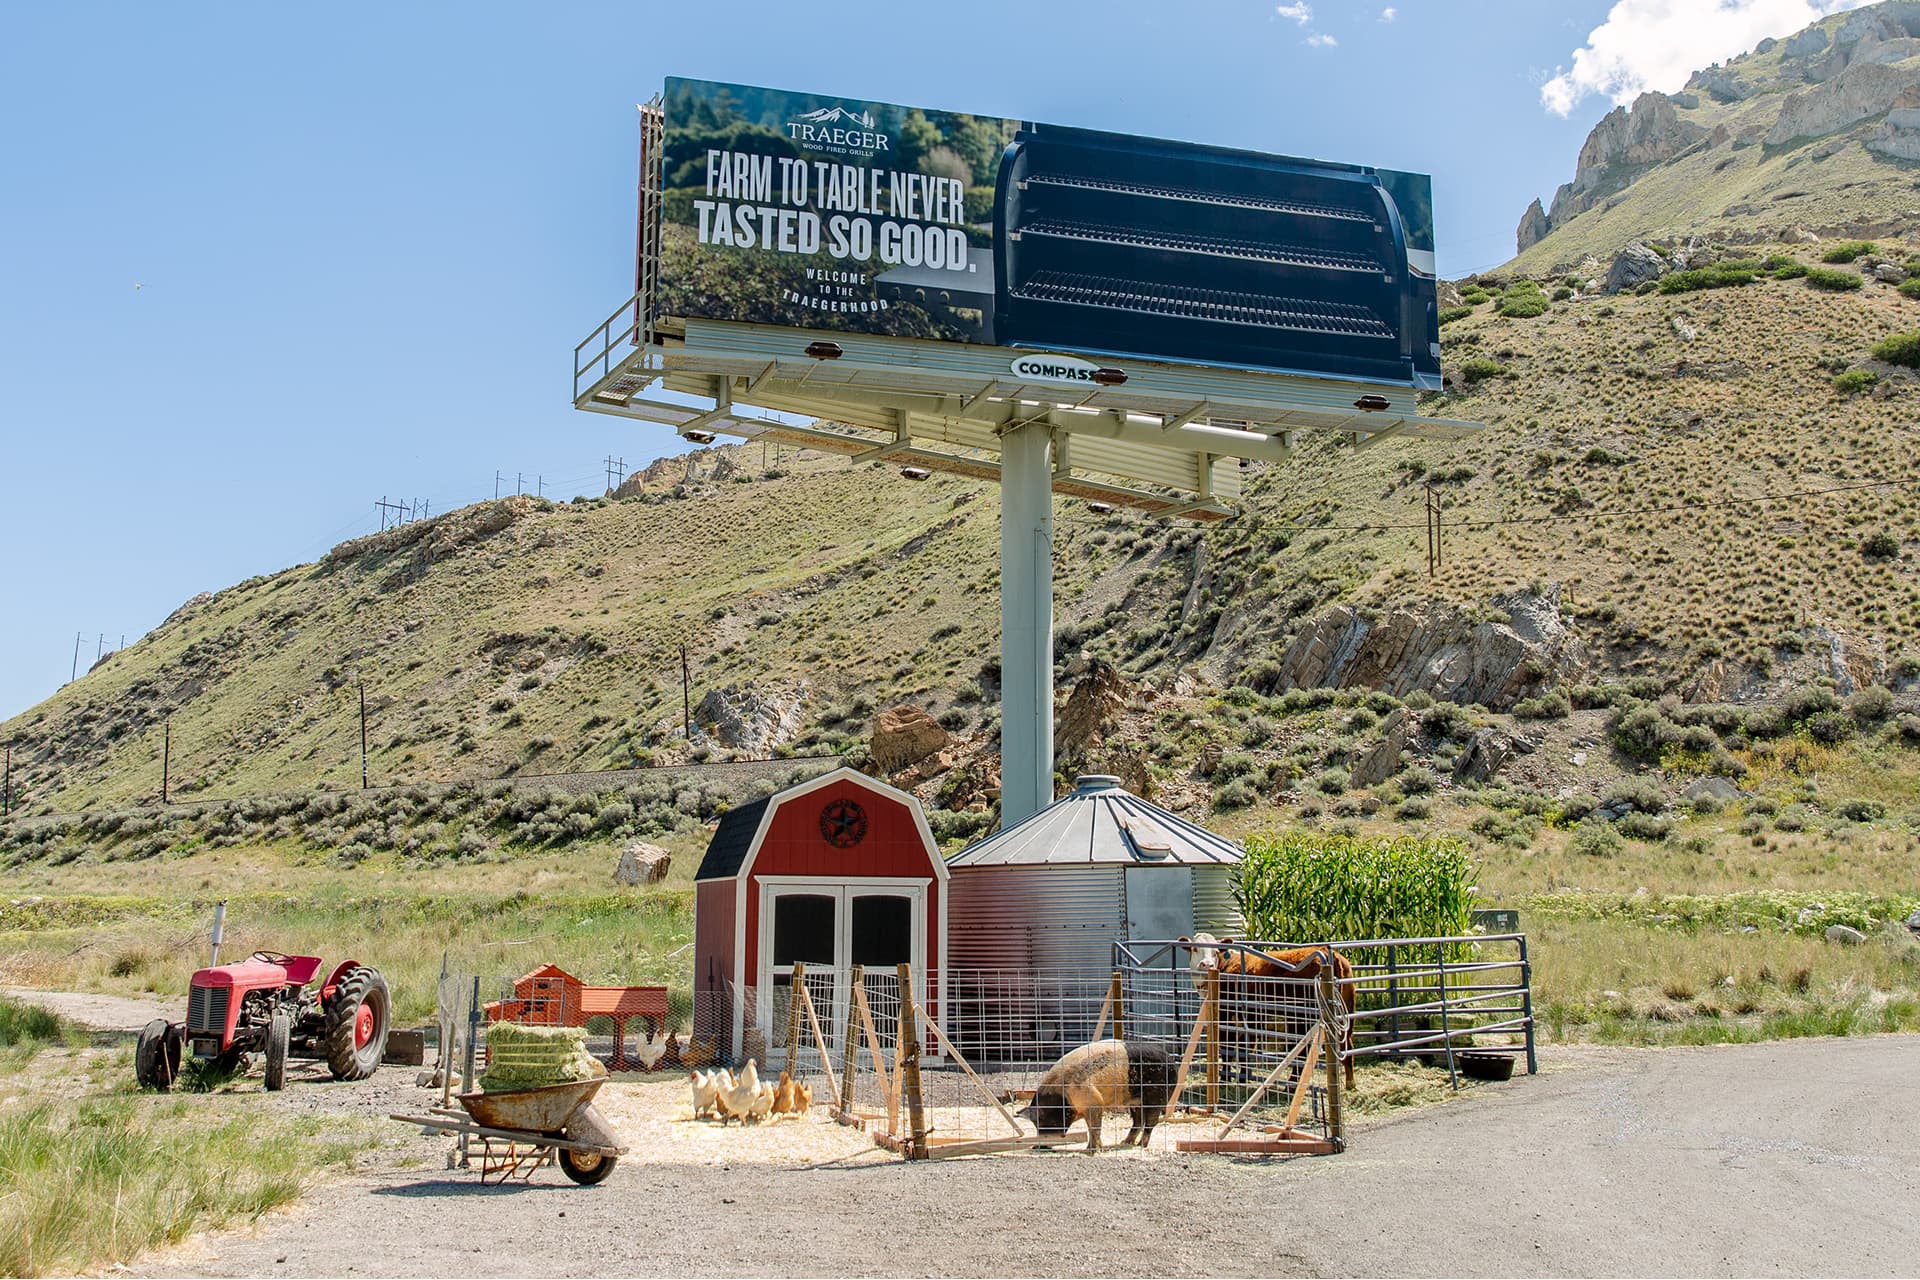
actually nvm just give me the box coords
[1000,422,1054,829]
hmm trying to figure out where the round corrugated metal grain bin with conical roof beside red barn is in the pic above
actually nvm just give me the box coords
[947,775,1240,1059]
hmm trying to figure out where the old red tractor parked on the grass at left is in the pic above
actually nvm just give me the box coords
[132,952,392,1090]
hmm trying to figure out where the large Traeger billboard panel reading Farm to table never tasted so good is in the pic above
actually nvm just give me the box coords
[655,79,1440,386]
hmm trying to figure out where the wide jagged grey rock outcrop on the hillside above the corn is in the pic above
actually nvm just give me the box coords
[1281,587,1590,710]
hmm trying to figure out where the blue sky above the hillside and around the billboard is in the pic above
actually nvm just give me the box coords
[0,0,1847,718]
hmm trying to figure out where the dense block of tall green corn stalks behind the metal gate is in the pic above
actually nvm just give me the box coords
[1235,833,1475,942]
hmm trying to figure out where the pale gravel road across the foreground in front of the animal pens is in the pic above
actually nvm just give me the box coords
[142,1036,1920,1276]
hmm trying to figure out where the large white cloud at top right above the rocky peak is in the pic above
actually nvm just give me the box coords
[1543,0,1868,115]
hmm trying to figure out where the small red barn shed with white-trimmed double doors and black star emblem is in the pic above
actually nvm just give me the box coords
[693,768,947,1054]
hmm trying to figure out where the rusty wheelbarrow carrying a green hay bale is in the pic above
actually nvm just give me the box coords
[392,1079,626,1186]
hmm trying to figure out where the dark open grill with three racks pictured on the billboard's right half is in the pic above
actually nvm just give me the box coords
[995,125,1440,388]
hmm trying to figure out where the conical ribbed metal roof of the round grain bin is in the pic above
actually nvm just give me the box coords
[947,773,1240,867]
